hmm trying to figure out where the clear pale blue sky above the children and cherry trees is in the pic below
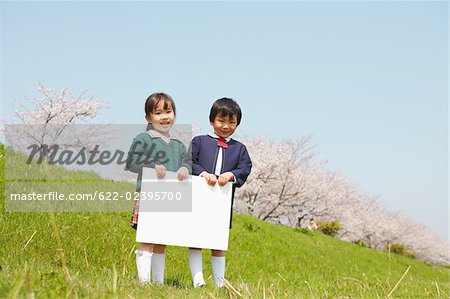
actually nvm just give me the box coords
[0,2,449,240]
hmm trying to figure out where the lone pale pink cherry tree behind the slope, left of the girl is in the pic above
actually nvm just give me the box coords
[2,83,110,157]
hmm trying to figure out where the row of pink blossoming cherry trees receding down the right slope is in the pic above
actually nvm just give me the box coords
[235,137,450,264]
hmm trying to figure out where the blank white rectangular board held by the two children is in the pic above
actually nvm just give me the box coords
[136,168,232,250]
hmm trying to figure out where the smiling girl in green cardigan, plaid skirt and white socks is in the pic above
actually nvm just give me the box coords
[127,93,191,284]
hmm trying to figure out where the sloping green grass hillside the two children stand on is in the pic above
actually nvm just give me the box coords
[0,147,450,298]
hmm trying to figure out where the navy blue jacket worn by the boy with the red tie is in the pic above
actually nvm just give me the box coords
[189,135,252,188]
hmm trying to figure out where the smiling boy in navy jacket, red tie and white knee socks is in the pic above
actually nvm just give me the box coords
[188,98,252,287]
